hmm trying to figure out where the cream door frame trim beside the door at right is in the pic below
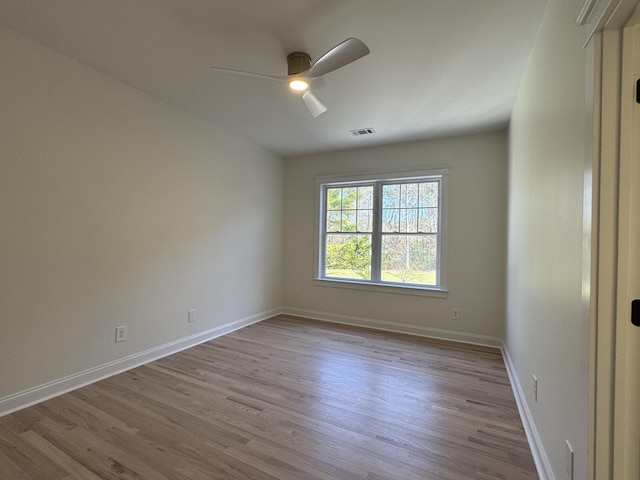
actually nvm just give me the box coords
[583,0,640,480]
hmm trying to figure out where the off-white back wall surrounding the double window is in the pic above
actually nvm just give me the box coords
[283,132,507,343]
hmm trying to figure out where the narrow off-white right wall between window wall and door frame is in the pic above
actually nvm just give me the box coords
[506,0,589,479]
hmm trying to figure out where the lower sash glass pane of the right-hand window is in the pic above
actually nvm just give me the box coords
[381,235,438,285]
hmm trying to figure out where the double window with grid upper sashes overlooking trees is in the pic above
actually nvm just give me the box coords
[317,169,448,291]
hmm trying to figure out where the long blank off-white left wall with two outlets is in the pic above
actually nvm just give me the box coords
[0,29,283,400]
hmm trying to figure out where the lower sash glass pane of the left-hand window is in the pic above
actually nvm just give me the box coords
[325,234,371,280]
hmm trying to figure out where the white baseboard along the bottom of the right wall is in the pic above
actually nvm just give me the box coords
[502,342,556,480]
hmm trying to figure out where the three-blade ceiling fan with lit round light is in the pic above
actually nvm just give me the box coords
[211,37,370,118]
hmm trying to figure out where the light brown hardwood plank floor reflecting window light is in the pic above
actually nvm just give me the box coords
[0,316,538,480]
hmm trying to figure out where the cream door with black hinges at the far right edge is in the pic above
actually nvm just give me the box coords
[613,17,640,480]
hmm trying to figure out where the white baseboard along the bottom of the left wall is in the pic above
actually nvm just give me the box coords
[0,308,281,417]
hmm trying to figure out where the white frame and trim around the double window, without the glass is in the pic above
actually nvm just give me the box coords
[314,166,450,297]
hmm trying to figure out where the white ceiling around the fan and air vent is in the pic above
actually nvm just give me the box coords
[0,0,546,156]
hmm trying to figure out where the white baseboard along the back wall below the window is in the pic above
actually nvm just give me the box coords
[282,307,502,348]
